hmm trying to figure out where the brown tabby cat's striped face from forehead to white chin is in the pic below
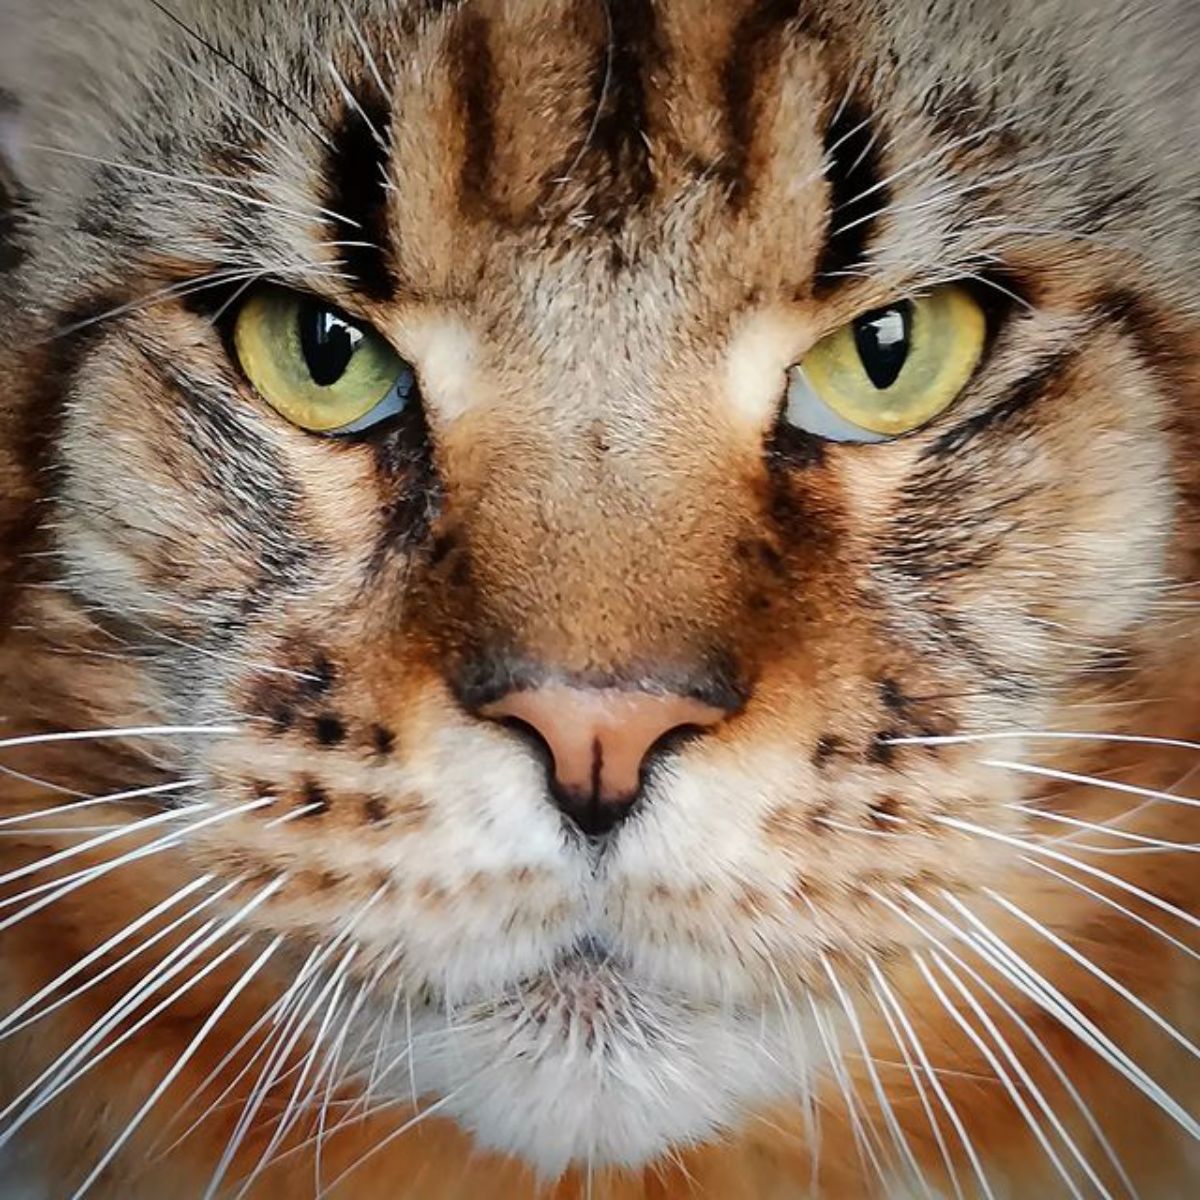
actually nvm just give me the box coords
[2,0,1195,1175]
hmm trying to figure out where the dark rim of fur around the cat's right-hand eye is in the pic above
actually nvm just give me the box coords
[764,266,1033,460]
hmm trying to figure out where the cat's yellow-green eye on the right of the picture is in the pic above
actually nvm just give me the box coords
[784,284,986,442]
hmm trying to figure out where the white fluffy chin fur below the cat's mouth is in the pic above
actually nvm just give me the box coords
[382,964,815,1178]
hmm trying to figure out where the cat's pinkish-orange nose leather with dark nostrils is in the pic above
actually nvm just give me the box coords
[479,685,730,835]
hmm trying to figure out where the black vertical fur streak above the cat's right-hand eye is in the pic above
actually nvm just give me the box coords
[817,101,889,290]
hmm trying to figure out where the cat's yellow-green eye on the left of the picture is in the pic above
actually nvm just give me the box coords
[234,288,416,433]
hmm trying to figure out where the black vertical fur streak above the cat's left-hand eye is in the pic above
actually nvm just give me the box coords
[325,90,396,300]
